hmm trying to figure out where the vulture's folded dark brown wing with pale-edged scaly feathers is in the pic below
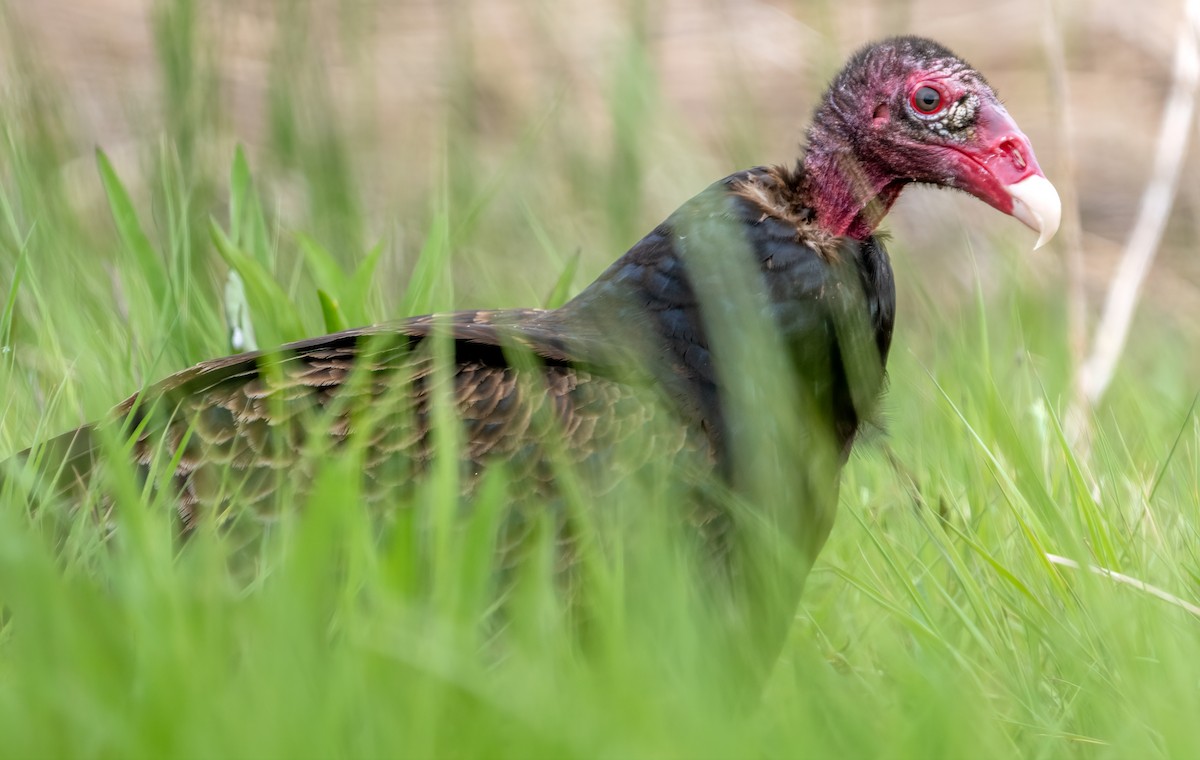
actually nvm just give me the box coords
[14,303,710,540]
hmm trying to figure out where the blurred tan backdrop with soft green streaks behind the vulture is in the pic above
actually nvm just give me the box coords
[0,0,1200,417]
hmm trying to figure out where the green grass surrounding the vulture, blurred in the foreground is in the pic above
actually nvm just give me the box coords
[0,2,1200,759]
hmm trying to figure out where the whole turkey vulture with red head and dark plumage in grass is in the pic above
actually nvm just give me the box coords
[2,37,1060,629]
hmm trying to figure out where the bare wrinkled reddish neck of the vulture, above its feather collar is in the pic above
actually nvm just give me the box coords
[803,134,907,241]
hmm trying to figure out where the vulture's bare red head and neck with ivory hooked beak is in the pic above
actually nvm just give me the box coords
[804,37,1061,247]
